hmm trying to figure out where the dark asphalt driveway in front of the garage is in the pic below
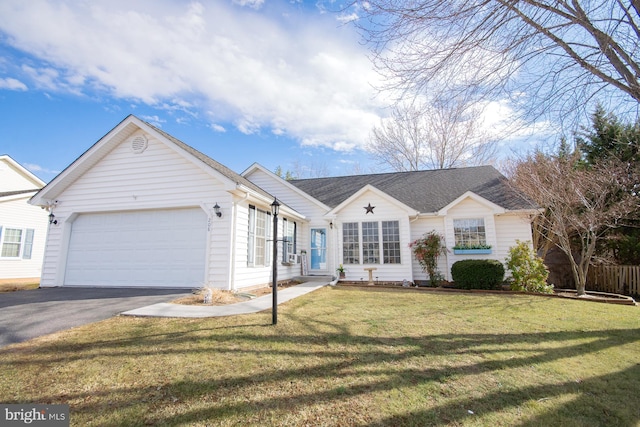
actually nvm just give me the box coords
[0,287,190,347]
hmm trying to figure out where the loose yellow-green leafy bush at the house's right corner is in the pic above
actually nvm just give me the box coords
[506,240,553,294]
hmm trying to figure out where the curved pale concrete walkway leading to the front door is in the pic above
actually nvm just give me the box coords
[121,278,335,317]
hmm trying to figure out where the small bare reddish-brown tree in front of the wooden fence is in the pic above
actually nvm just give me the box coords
[510,152,638,295]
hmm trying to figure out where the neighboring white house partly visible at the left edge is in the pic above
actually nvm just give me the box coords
[0,155,49,281]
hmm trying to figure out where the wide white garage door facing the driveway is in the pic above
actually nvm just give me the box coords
[65,208,207,288]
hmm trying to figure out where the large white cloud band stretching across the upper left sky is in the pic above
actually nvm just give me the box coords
[0,0,384,150]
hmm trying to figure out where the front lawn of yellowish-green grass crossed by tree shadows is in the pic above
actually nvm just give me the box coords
[0,288,640,426]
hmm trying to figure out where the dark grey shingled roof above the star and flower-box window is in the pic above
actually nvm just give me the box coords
[289,166,535,213]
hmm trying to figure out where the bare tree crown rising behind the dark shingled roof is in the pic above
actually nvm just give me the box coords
[369,98,496,171]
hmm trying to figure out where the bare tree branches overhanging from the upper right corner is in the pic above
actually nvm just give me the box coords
[355,0,640,129]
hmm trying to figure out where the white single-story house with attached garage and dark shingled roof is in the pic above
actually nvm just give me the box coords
[30,116,534,290]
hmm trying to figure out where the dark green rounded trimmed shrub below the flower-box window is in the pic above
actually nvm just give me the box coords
[451,259,504,289]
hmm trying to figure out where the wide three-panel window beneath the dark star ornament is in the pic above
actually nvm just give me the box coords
[342,221,401,264]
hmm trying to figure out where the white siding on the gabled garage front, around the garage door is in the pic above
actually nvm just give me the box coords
[36,131,231,289]
